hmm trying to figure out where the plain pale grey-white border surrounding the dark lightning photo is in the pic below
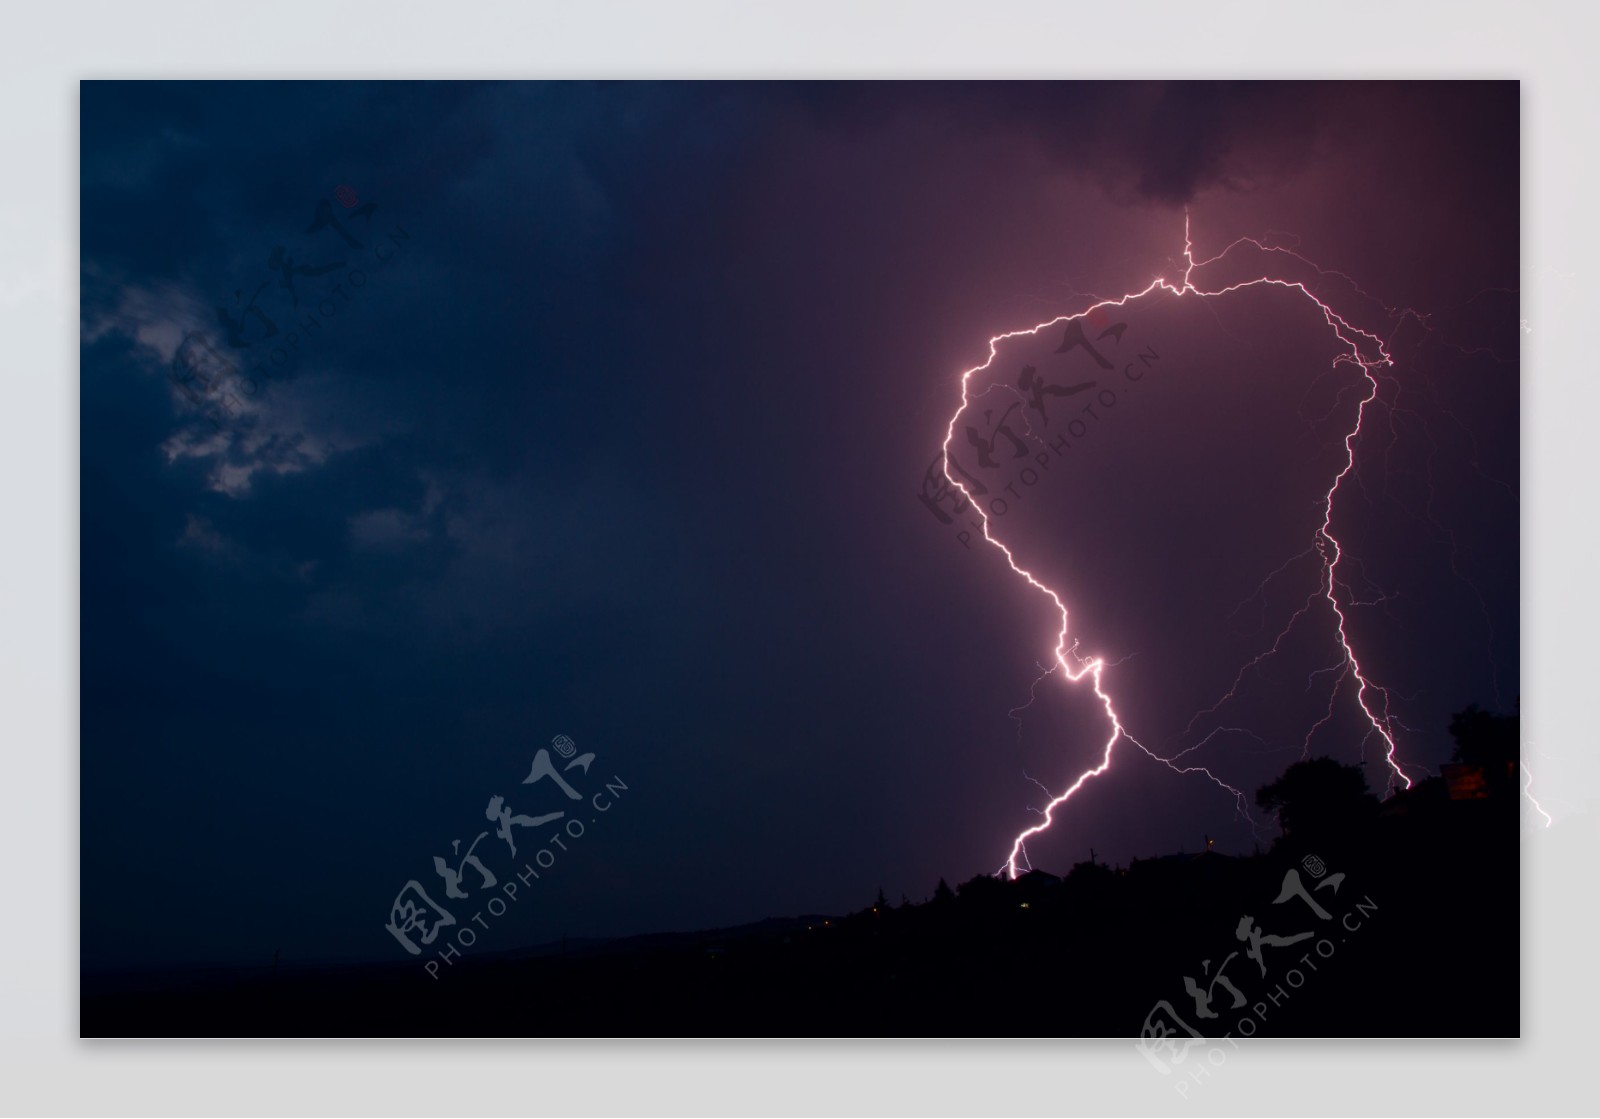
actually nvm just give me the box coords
[0,0,1600,1116]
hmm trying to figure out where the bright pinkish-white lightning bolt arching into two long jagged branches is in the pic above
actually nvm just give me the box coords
[942,213,1411,877]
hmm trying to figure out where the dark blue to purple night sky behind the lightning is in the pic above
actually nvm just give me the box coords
[80,82,1520,970]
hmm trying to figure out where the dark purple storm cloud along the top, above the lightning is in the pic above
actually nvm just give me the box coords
[787,82,1518,219]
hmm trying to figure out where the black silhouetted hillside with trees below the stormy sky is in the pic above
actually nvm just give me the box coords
[82,706,1522,1037]
